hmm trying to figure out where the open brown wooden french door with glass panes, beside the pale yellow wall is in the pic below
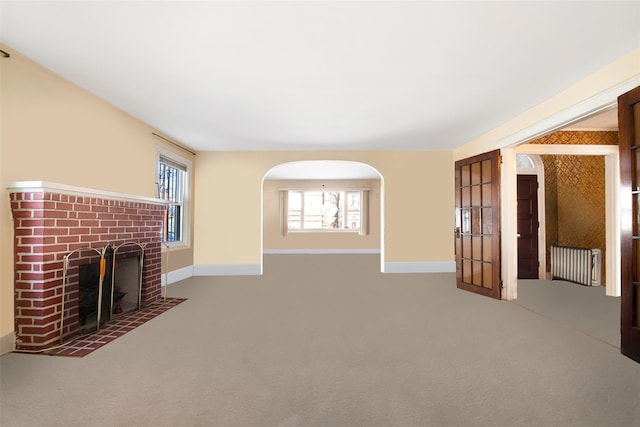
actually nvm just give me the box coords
[455,150,501,299]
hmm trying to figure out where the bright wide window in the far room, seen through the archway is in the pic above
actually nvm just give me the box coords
[287,190,362,232]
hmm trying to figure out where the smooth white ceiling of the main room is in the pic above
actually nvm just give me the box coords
[0,1,640,150]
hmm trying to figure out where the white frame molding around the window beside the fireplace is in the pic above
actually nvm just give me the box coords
[154,147,193,249]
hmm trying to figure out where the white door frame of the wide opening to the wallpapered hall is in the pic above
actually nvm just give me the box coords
[494,76,640,300]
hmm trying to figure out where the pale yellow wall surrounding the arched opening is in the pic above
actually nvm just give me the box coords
[194,151,453,265]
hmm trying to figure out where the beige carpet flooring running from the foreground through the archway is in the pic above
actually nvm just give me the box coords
[0,255,640,427]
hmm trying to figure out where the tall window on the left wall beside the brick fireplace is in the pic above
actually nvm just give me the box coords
[158,153,190,243]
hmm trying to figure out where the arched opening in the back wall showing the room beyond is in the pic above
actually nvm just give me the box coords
[261,160,384,271]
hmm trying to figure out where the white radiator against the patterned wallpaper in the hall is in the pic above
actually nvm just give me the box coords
[551,246,602,286]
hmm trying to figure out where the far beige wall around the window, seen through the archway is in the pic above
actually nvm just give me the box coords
[263,180,381,250]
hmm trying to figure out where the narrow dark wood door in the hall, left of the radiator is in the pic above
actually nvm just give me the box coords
[517,175,539,279]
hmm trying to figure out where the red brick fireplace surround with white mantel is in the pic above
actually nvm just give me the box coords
[9,181,166,351]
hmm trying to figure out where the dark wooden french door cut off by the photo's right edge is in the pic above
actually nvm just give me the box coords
[618,87,640,362]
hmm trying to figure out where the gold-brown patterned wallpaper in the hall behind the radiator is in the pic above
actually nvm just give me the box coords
[531,131,618,285]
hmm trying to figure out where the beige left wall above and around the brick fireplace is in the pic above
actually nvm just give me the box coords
[0,46,193,352]
